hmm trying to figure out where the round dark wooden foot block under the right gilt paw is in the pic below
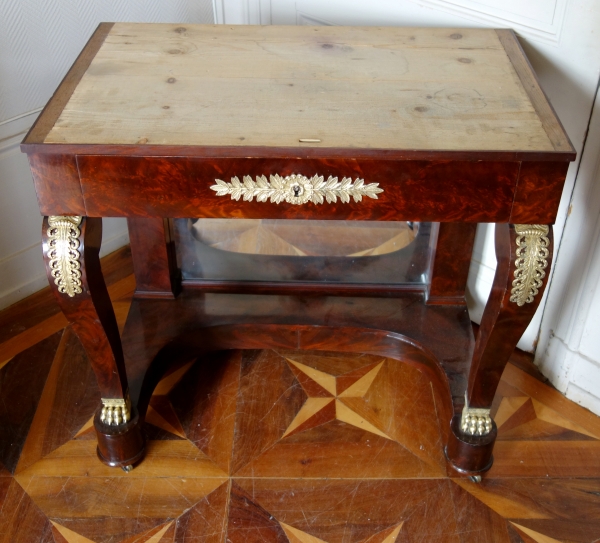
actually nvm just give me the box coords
[445,415,498,476]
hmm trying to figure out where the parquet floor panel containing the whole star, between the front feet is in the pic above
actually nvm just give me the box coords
[234,351,445,478]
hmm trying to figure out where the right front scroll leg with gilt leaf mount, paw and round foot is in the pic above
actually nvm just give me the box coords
[447,224,552,475]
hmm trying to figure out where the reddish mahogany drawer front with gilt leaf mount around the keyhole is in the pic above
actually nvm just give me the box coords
[77,156,519,222]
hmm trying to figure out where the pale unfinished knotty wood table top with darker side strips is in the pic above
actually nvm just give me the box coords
[24,23,573,155]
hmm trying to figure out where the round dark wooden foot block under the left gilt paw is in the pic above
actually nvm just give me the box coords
[94,412,146,468]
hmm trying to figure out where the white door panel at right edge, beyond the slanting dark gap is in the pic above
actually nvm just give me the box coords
[536,81,600,414]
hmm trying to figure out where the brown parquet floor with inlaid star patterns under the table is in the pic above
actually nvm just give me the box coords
[0,250,600,543]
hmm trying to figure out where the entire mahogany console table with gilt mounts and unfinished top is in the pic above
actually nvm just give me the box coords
[22,23,575,479]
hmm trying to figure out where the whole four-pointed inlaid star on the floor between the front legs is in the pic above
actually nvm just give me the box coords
[282,358,392,439]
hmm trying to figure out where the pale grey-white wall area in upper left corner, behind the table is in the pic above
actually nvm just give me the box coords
[0,0,213,122]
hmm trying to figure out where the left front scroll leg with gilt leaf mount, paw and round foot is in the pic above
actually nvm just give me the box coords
[42,216,144,467]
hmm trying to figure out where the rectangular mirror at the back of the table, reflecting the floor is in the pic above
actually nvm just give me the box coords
[173,219,435,292]
